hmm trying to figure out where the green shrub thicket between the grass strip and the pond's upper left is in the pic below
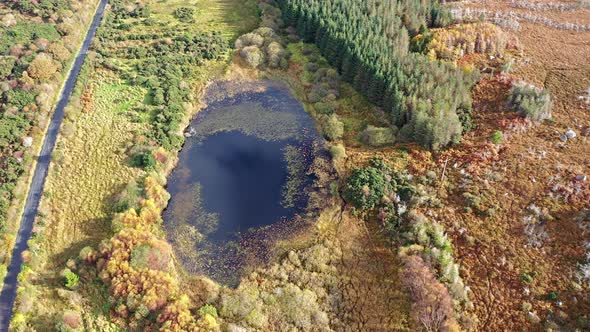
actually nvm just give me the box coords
[97,1,228,150]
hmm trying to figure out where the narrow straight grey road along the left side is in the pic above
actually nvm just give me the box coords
[0,0,108,332]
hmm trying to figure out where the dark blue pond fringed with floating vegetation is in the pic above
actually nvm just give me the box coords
[164,81,321,285]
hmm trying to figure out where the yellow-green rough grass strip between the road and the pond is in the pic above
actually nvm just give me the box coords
[43,73,146,255]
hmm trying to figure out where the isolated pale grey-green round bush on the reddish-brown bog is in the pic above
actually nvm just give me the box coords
[508,82,552,122]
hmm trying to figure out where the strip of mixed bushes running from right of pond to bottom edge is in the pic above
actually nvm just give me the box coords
[342,158,477,331]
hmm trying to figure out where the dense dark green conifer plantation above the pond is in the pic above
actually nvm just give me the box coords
[278,0,473,149]
